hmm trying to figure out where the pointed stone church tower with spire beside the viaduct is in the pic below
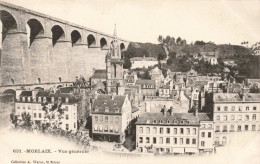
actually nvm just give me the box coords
[106,25,124,94]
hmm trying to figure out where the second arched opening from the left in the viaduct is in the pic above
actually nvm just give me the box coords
[26,19,44,47]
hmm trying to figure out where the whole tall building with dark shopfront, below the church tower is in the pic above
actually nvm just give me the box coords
[91,95,132,143]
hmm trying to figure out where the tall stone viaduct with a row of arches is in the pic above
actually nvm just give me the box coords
[0,2,129,92]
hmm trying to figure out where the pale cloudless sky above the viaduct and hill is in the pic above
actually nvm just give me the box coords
[3,0,260,45]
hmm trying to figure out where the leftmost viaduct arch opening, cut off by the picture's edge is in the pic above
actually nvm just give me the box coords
[0,10,17,49]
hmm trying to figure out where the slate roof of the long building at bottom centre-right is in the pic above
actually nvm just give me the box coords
[136,112,199,126]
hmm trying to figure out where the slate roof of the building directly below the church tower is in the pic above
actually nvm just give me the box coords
[92,95,126,114]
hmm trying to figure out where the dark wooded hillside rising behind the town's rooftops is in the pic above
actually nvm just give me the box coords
[123,36,260,78]
